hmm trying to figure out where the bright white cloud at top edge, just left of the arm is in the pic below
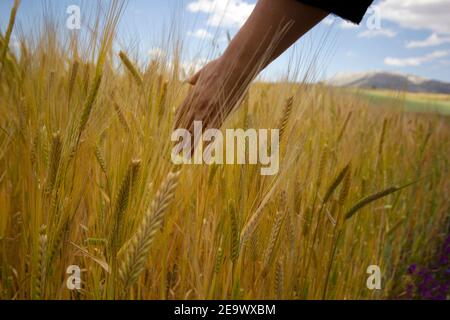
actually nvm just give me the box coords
[187,0,255,28]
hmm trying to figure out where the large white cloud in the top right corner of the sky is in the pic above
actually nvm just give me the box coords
[376,0,450,34]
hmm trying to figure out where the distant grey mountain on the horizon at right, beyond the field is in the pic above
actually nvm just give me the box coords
[327,71,450,94]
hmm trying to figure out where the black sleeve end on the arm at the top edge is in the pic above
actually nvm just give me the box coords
[298,0,373,23]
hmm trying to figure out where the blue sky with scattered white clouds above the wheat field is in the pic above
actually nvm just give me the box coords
[0,0,450,82]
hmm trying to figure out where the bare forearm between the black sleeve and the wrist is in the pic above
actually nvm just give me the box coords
[224,0,327,74]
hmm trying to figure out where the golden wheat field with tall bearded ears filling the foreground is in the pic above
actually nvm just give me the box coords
[0,1,450,299]
